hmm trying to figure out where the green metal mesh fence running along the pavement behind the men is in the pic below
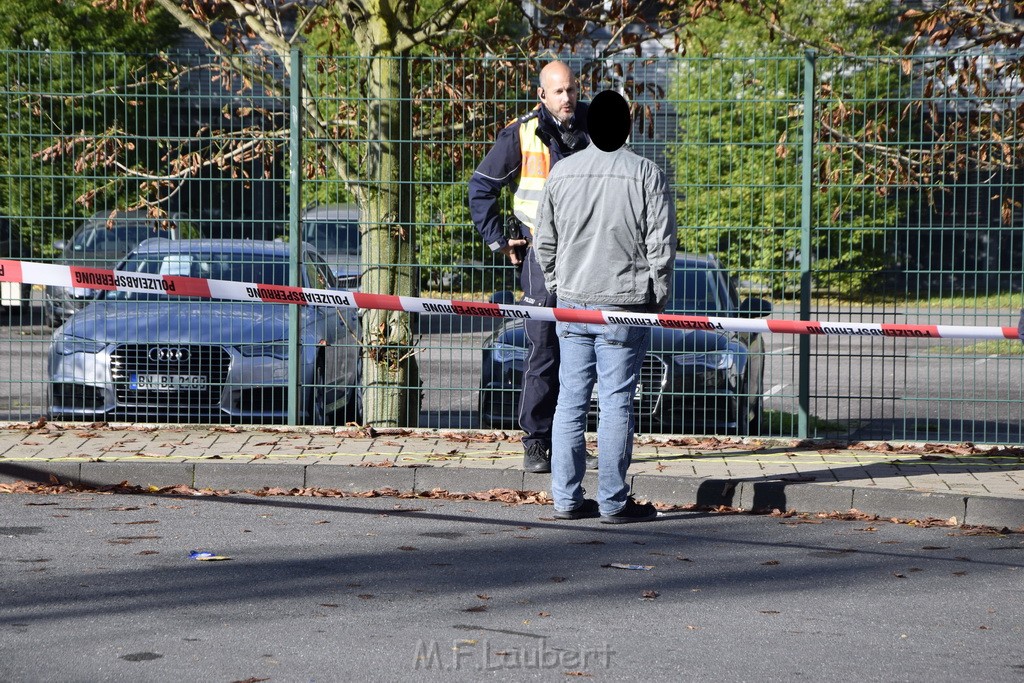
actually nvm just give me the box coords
[0,52,1024,443]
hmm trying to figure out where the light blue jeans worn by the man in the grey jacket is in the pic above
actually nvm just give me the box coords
[551,300,650,515]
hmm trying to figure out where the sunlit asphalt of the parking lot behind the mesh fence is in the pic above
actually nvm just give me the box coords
[0,293,1024,443]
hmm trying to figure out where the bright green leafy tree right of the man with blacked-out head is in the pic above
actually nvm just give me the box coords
[670,1,911,293]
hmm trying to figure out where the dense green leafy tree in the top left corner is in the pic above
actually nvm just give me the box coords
[0,0,174,250]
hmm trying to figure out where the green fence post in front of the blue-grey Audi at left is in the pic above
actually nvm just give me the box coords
[288,47,302,425]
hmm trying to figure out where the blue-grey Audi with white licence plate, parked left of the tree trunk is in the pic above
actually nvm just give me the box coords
[48,238,360,424]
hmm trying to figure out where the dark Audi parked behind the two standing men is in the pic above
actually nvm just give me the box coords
[479,255,771,434]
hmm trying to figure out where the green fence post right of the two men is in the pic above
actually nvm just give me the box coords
[797,50,817,438]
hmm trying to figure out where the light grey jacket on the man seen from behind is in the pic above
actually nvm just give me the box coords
[534,145,676,311]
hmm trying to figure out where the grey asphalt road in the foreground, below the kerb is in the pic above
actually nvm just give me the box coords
[0,494,1024,682]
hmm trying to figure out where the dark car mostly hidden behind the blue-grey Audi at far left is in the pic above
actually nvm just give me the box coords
[43,210,193,327]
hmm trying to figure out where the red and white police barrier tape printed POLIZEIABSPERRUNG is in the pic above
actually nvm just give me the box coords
[0,259,1020,340]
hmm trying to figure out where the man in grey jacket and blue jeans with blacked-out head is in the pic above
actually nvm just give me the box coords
[535,90,676,523]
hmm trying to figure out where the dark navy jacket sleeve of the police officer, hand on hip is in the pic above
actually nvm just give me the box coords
[469,123,522,251]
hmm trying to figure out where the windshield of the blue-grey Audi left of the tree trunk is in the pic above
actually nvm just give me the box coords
[105,251,289,301]
